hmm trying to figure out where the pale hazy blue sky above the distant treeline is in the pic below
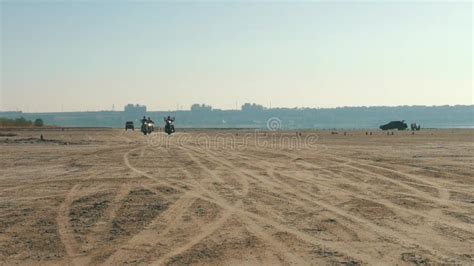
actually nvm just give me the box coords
[0,0,473,112]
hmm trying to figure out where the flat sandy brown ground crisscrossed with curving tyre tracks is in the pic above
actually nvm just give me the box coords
[0,129,474,265]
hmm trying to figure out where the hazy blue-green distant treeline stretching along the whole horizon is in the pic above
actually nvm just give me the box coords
[0,103,474,130]
